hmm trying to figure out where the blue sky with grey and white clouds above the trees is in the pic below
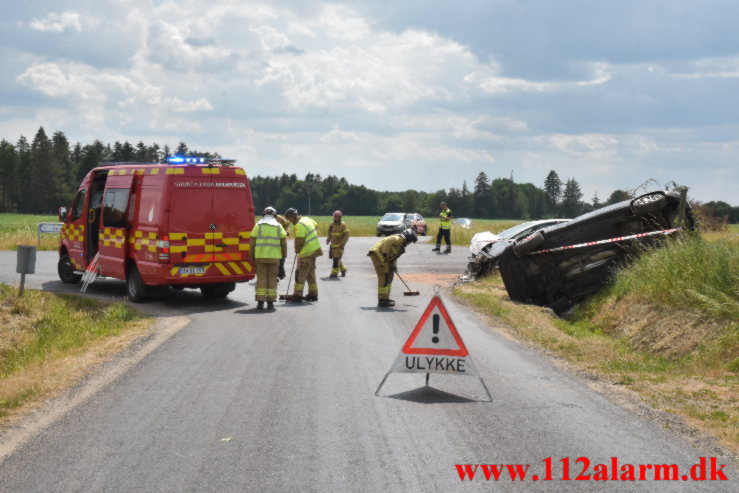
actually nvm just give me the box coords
[0,0,739,205]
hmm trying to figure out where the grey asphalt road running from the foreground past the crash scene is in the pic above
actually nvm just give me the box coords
[0,238,737,492]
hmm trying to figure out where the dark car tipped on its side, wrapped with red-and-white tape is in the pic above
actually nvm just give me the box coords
[498,191,695,313]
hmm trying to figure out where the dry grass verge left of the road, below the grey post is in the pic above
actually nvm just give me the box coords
[0,284,151,427]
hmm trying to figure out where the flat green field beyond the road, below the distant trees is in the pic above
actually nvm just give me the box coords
[0,214,523,250]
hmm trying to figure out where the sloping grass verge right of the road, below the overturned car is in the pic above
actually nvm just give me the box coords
[455,233,739,454]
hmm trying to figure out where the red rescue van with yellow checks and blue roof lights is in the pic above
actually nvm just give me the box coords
[58,158,255,301]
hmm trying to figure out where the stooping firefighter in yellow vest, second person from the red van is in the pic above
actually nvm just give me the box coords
[285,208,323,303]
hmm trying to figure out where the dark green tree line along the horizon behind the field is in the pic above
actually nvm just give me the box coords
[0,127,739,222]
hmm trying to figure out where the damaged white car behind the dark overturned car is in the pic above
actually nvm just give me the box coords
[463,219,569,281]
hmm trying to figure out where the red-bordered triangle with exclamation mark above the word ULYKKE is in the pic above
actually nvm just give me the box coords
[401,296,469,357]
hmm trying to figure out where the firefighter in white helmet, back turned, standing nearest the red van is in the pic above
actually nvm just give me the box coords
[250,207,287,310]
